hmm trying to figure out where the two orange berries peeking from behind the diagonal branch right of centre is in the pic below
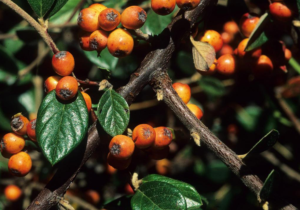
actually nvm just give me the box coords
[172,82,203,120]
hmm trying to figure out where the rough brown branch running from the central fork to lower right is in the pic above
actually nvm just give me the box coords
[152,71,297,210]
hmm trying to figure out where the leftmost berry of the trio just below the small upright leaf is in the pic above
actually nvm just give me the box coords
[108,135,135,159]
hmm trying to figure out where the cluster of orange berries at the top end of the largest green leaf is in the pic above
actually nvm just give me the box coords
[44,51,92,111]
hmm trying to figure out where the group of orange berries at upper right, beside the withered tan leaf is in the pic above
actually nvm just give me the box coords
[199,6,292,78]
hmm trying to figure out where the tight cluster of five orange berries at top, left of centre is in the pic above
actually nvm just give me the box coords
[77,3,147,57]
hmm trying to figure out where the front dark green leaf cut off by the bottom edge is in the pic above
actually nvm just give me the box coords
[131,181,187,210]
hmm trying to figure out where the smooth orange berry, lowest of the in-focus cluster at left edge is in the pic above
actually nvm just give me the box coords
[8,152,32,177]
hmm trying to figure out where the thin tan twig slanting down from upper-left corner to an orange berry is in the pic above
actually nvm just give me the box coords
[0,0,59,54]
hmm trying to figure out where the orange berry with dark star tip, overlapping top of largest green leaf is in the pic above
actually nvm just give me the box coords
[55,76,78,101]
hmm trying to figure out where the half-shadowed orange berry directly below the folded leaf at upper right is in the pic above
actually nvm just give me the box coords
[253,55,273,78]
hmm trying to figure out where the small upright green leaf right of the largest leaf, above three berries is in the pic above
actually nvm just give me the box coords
[96,89,130,136]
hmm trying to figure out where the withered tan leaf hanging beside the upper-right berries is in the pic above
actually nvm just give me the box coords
[190,36,216,71]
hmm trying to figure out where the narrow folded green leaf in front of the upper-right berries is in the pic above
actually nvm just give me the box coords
[245,13,271,52]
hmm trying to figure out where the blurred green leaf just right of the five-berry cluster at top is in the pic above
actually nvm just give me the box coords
[141,7,177,35]
